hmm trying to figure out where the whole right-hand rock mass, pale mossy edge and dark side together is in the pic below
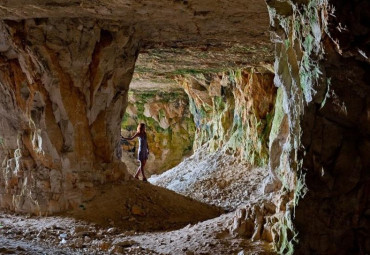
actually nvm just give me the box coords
[268,0,370,254]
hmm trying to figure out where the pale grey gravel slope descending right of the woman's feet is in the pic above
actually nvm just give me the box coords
[149,145,268,211]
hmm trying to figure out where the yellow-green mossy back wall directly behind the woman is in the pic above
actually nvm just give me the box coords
[121,88,195,175]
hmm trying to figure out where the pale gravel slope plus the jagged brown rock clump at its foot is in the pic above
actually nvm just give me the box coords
[149,145,288,247]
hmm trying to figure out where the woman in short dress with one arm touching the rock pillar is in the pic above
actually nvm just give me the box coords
[123,123,149,182]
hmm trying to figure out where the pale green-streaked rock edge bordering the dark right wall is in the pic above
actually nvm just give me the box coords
[267,0,329,254]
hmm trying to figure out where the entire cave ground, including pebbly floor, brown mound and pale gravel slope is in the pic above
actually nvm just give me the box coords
[0,150,274,255]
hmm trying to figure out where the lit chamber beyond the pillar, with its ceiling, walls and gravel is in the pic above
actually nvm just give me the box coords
[121,42,276,213]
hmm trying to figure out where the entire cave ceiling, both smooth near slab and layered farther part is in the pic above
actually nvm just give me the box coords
[0,0,273,86]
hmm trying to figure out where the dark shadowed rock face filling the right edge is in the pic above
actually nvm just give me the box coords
[295,1,370,254]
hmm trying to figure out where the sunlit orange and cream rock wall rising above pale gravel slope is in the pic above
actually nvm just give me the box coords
[180,67,276,166]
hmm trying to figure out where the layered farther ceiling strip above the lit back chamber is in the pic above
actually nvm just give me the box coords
[133,43,274,85]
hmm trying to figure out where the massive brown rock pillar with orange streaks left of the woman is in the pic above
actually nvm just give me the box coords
[0,19,138,213]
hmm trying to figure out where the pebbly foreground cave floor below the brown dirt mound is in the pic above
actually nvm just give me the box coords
[0,213,274,254]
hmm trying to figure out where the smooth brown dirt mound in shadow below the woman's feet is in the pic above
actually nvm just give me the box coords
[68,181,221,231]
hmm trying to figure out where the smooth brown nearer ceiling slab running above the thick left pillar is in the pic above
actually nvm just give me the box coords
[0,0,269,47]
